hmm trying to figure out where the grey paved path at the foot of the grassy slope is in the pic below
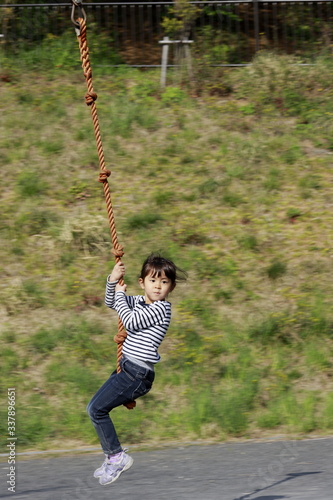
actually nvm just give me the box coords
[0,438,333,500]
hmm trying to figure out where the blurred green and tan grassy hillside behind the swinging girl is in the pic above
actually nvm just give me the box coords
[0,54,333,449]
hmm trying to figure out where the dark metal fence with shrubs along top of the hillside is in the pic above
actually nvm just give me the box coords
[0,0,333,67]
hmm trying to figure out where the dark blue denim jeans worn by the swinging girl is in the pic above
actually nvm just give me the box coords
[87,358,155,455]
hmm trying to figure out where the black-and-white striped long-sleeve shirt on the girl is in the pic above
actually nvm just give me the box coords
[105,281,171,363]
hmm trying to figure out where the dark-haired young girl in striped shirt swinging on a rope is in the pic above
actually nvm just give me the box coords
[87,254,186,485]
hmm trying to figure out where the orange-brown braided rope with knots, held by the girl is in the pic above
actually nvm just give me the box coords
[78,18,135,409]
